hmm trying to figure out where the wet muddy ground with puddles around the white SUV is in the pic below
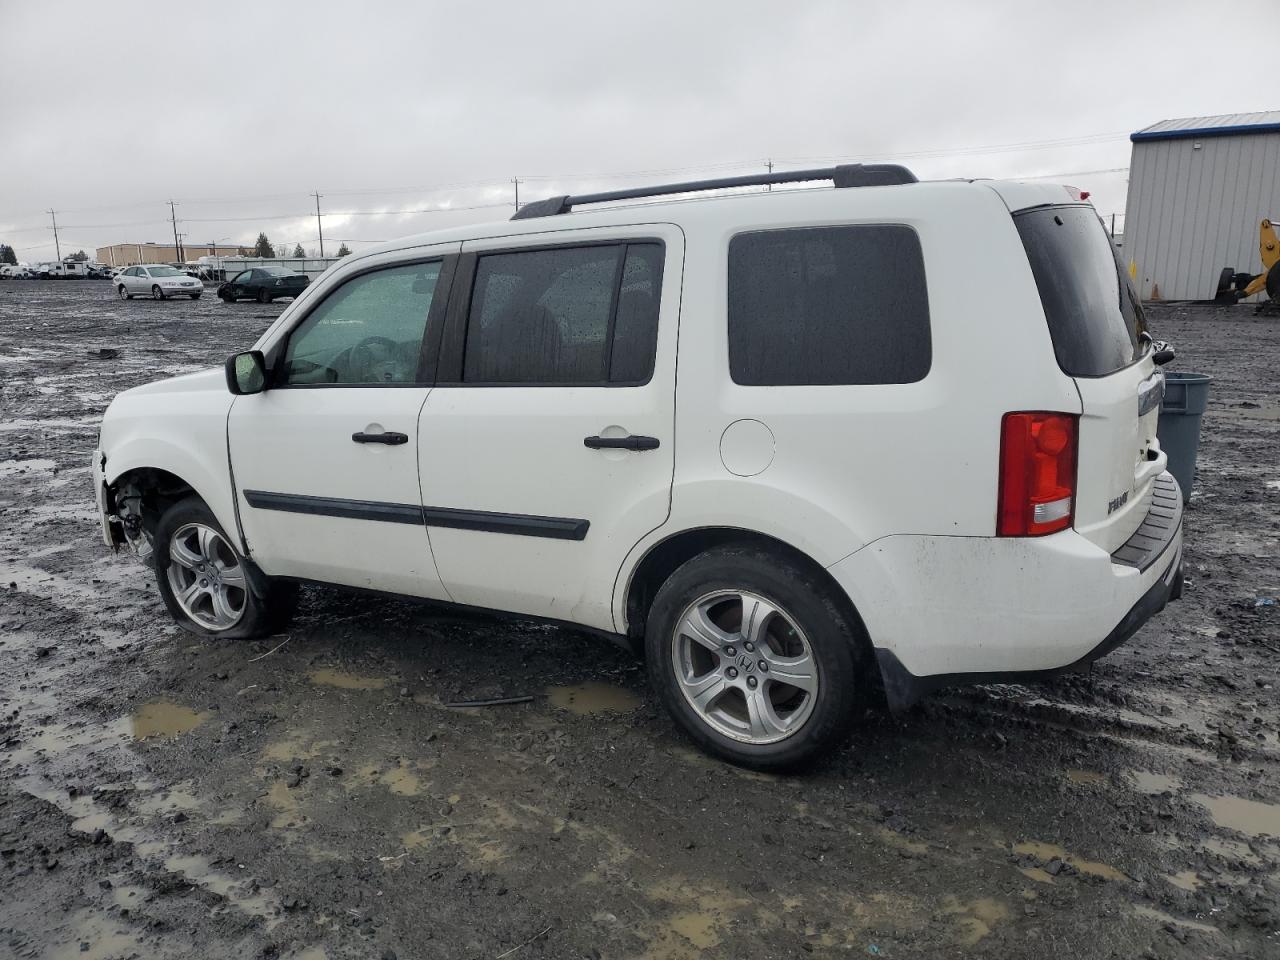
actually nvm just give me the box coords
[0,282,1280,960]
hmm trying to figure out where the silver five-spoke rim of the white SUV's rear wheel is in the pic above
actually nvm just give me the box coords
[671,590,819,744]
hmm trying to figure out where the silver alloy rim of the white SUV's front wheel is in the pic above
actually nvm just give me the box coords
[168,524,248,632]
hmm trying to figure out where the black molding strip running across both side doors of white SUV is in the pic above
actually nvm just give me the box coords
[243,490,591,540]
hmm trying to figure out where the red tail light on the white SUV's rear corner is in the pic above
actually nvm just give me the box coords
[996,413,1079,536]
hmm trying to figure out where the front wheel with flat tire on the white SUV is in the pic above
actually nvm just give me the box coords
[154,497,297,640]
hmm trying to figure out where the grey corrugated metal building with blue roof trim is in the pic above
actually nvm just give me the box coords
[1124,110,1280,300]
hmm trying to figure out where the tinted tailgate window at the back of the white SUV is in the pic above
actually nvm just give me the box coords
[1014,206,1143,376]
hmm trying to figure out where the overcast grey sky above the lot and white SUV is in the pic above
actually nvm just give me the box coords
[0,0,1280,261]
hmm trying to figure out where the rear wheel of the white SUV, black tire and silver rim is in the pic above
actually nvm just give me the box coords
[645,545,868,771]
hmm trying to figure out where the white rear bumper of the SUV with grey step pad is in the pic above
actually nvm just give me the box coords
[829,474,1183,708]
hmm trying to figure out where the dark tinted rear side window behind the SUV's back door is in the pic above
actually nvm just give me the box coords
[728,224,932,387]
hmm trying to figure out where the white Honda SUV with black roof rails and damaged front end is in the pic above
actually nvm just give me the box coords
[93,165,1181,768]
